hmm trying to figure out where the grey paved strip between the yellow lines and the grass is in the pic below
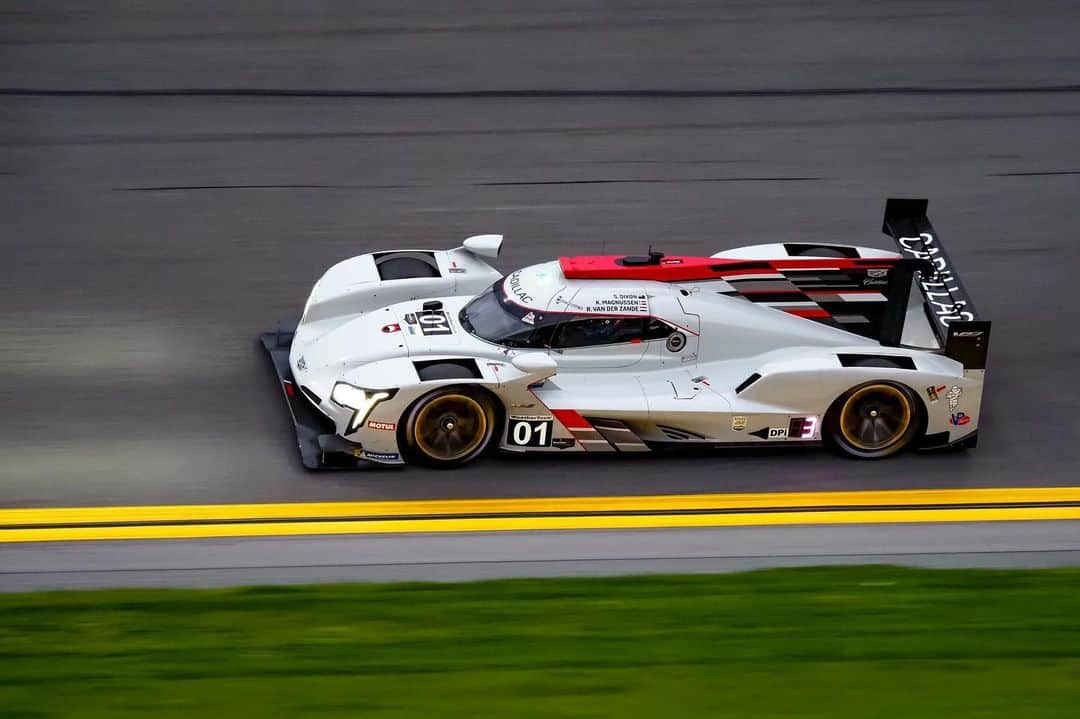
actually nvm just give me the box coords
[0,521,1080,592]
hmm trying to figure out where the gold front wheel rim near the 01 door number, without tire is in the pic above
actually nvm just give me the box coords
[413,394,487,462]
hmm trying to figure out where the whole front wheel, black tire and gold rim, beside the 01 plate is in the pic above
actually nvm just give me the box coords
[399,386,499,469]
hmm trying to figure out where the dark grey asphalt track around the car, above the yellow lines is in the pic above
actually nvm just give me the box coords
[0,0,1080,582]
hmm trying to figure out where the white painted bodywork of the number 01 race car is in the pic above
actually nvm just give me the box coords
[288,235,983,464]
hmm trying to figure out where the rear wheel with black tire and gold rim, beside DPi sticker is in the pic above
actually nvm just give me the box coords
[825,380,924,459]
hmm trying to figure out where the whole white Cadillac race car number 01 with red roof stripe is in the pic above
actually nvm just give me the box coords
[261,200,990,469]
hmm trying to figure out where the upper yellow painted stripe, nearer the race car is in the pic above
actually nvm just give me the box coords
[0,487,1080,527]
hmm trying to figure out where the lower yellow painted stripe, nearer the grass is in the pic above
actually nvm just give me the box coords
[0,506,1080,543]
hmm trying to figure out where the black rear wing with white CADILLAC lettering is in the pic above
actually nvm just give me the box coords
[881,199,990,369]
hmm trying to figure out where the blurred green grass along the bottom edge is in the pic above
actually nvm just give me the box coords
[0,567,1080,719]
